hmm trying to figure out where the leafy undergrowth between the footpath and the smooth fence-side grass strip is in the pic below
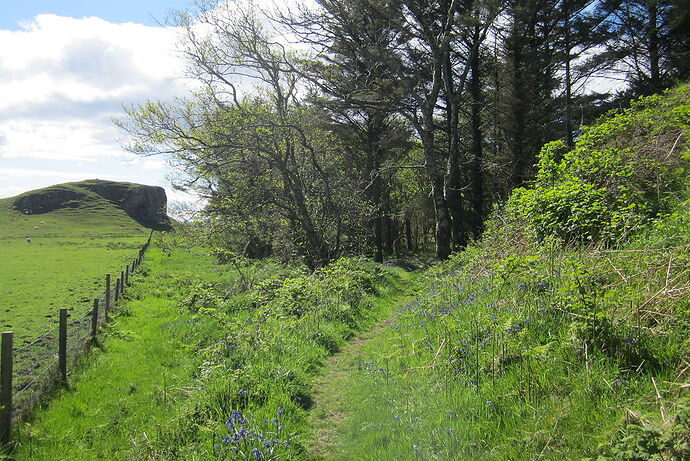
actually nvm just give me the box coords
[148,253,392,459]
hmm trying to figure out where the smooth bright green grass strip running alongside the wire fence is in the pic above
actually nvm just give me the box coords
[16,250,224,460]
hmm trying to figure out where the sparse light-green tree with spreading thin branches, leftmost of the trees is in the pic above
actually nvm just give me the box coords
[121,2,358,269]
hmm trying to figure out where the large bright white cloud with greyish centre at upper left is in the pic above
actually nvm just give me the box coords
[0,15,184,117]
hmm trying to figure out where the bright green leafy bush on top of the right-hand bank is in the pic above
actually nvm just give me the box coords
[508,87,690,243]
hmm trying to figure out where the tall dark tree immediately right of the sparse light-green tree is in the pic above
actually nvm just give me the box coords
[281,0,410,262]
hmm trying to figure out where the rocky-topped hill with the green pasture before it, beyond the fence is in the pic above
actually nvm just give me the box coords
[0,180,168,345]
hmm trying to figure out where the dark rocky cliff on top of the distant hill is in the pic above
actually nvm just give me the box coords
[12,179,170,228]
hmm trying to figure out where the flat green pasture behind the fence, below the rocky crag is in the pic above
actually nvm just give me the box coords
[0,187,150,414]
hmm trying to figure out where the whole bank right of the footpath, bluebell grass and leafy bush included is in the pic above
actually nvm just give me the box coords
[312,85,690,460]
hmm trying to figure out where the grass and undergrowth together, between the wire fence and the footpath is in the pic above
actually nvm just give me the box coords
[16,235,414,460]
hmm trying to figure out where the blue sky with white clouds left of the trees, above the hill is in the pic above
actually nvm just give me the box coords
[0,0,195,202]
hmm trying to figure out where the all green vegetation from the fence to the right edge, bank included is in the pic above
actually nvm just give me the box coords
[12,85,690,460]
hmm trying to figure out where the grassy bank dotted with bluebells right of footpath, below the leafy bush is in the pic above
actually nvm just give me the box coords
[310,208,690,460]
